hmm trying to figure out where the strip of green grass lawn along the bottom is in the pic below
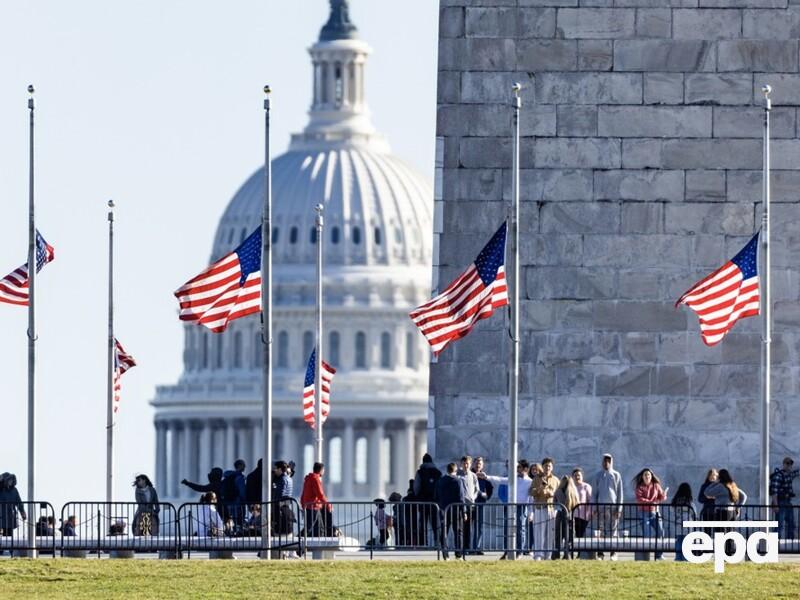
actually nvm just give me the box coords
[0,559,800,600]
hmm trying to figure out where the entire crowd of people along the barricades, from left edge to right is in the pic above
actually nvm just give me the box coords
[0,454,800,560]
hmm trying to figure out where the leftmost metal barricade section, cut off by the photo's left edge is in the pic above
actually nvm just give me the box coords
[0,502,56,556]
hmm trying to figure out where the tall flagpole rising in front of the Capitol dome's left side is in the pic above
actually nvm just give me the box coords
[261,85,272,560]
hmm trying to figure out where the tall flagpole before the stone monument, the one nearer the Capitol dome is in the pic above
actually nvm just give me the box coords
[508,83,522,559]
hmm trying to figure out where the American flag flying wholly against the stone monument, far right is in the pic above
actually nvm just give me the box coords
[675,234,760,346]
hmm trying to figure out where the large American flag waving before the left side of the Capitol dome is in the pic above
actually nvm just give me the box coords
[175,227,261,333]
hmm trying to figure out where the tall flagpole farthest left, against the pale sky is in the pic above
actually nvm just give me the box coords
[28,85,36,557]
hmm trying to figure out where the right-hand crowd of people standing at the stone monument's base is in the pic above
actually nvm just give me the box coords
[403,454,800,561]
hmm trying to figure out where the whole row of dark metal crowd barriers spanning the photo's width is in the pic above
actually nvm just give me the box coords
[0,499,800,559]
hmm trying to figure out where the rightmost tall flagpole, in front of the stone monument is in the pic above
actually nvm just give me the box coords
[759,85,772,517]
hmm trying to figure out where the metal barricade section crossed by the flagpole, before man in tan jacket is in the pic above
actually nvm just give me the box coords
[439,502,572,560]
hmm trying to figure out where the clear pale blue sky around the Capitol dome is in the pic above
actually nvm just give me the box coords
[0,0,438,510]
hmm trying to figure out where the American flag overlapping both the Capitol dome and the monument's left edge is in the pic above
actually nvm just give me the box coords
[410,223,508,354]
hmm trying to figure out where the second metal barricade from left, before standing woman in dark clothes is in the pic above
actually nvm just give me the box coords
[60,502,178,556]
